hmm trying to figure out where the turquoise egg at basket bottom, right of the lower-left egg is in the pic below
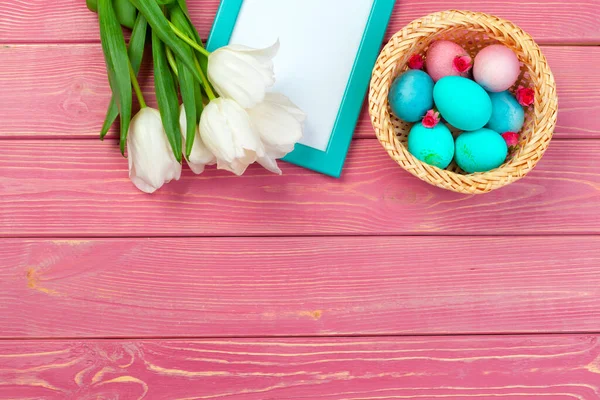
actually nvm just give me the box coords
[454,128,508,174]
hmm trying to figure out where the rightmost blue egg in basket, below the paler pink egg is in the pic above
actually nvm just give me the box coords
[486,91,525,133]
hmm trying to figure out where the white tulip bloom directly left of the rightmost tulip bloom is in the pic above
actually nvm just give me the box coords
[200,97,265,176]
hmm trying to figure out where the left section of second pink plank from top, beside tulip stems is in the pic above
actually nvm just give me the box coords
[0,44,156,138]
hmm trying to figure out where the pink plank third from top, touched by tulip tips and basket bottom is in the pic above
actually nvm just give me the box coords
[0,140,600,237]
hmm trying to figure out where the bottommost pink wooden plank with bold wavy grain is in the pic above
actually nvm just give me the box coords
[0,335,600,400]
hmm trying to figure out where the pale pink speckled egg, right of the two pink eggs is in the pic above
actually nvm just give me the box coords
[473,44,521,92]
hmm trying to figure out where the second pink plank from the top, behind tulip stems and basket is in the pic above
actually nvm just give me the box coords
[0,44,600,138]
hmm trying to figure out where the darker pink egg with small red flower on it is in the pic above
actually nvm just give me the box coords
[425,40,471,82]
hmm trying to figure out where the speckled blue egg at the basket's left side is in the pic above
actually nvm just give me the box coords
[388,69,433,122]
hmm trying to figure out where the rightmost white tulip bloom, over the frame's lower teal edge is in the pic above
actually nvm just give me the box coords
[248,93,306,174]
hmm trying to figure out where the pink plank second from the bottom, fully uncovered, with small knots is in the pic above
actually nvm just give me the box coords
[0,236,600,338]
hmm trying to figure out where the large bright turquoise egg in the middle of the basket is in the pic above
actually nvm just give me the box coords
[433,76,492,131]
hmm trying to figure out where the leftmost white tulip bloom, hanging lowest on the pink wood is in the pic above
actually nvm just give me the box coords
[127,107,181,193]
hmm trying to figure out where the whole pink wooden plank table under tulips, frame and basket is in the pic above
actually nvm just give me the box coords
[0,0,600,400]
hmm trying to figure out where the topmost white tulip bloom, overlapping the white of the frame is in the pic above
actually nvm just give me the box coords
[208,41,279,108]
